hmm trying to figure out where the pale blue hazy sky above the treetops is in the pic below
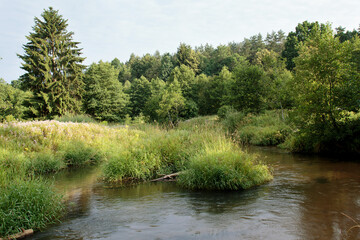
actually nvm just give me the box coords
[0,0,360,82]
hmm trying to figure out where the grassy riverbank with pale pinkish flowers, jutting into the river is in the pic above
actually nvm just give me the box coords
[0,118,272,236]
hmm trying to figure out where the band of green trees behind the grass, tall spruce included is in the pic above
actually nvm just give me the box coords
[0,8,360,153]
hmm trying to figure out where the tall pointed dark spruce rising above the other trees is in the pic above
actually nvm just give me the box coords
[18,7,85,118]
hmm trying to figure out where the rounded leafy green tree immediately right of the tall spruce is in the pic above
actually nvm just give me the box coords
[84,61,128,121]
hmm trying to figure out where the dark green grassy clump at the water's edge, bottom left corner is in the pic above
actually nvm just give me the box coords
[0,178,64,236]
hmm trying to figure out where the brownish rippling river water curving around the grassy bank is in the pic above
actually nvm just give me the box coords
[31,148,360,240]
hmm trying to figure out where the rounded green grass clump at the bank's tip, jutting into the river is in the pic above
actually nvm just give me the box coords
[178,150,272,190]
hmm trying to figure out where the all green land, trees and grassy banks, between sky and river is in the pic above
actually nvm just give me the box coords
[0,7,360,239]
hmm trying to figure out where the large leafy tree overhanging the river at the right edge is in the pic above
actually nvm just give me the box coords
[294,25,360,150]
